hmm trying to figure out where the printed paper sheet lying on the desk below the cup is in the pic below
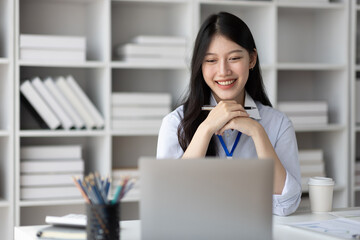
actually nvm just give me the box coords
[290,217,360,239]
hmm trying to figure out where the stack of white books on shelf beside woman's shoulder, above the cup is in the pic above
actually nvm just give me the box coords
[278,101,328,126]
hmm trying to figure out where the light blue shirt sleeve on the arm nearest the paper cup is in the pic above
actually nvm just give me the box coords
[273,117,301,216]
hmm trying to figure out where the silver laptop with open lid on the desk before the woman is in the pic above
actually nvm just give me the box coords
[139,157,273,240]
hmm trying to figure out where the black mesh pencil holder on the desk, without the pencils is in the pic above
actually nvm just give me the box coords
[86,203,120,240]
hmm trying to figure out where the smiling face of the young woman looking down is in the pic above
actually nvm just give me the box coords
[202,35,256,104]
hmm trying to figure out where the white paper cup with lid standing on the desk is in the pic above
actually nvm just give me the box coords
[308,177,334,213]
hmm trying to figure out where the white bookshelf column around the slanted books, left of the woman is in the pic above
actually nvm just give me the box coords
[15,0,111,225]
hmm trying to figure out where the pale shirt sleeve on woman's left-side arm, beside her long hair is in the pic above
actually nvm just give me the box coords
[156,112,184,159]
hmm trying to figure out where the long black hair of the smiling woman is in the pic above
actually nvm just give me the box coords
[178,12,271,156]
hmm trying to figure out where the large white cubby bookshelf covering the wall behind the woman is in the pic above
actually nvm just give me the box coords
[7,0,352,234]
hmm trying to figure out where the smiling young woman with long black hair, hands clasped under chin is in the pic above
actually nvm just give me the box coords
[157,12,301,215]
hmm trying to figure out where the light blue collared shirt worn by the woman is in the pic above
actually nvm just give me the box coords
[156,94,301,215]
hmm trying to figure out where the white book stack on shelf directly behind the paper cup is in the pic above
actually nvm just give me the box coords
[299,149,326,191]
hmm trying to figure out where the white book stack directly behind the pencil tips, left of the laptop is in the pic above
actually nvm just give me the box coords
[110,168,140,200]
